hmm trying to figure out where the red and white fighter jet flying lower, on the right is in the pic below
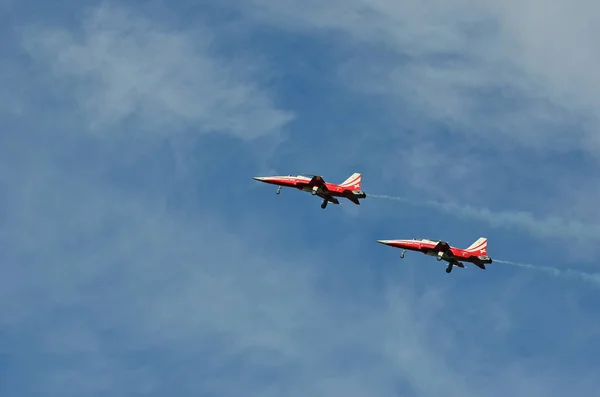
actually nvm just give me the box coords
[377,237,492,273]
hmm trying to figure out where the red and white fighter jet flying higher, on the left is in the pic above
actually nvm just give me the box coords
[253,172,367,209]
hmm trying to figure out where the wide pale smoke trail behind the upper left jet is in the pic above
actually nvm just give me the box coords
[367,194,600,239]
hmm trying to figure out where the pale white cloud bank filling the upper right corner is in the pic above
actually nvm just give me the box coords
[230,0,600,150]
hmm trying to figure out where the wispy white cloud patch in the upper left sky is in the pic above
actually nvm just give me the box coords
[16,2,293,139]
